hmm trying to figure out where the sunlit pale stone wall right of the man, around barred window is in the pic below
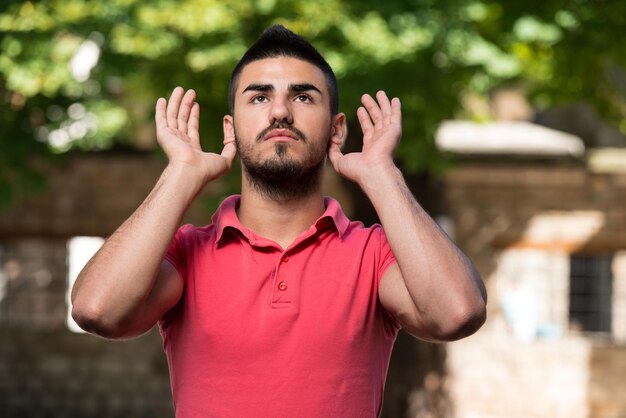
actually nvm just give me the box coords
[444,158,626,418]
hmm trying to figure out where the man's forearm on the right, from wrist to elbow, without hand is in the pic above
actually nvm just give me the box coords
[359,164,486,332]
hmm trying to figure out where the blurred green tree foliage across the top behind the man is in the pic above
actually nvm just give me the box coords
[0,0,626,204]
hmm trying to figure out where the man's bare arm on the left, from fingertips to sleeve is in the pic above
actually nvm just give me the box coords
[72,87,235,338]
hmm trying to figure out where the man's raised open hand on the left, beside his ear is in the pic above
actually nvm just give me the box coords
[155,87,236,181]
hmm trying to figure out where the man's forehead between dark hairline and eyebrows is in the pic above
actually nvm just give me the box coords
[237,57,328,95]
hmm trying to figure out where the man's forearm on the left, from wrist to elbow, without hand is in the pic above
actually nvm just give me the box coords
[72,166,202,334]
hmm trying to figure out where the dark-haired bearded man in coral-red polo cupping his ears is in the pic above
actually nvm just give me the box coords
[72,26,486,417]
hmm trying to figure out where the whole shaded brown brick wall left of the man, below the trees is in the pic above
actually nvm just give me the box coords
[0,155,173,417]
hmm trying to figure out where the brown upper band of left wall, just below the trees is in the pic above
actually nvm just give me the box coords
[0,153,229,237]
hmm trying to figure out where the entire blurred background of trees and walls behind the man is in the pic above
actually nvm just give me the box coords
[0,0,626,418]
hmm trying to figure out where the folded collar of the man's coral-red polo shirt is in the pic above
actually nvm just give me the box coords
[211,195,350,242]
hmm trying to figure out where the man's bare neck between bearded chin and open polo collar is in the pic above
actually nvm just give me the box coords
[237,173,325,248]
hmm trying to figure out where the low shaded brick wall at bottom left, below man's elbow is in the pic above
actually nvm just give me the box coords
[0,327,173,417]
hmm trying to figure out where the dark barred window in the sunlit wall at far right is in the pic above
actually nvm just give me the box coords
[569,254,613,333]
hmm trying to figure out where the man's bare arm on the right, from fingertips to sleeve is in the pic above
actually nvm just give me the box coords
[329,92,487,341]
